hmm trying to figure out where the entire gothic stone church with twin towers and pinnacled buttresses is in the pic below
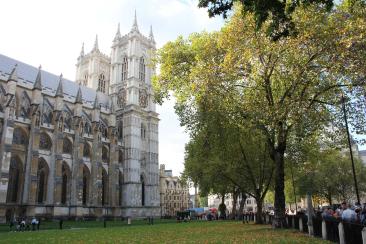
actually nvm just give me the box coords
[0,16,160,222]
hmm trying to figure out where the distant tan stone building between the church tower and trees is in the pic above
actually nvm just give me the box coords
[160,164,189,217]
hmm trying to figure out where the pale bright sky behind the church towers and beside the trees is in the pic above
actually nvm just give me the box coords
[0,0,224,174]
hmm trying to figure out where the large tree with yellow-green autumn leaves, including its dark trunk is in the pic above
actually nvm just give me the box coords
[154,1,366,227]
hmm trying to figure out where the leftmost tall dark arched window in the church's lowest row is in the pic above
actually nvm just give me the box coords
[6,157,23,203]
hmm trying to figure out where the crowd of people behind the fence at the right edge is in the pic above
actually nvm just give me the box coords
[322,202,366,225]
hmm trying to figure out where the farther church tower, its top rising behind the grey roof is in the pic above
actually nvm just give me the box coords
[75,36,111,95]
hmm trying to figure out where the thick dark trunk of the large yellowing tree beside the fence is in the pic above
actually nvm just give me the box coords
[272,150,287,228]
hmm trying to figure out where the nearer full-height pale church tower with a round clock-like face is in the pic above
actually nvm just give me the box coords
[109,13,160,216]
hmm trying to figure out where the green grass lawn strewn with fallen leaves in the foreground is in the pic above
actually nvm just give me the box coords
[0,221,328,243]
